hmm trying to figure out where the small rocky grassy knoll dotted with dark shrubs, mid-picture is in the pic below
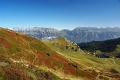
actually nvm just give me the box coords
[45,38,82,53]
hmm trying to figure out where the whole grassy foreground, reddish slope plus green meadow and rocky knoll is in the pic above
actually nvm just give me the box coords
[0,28,120,80]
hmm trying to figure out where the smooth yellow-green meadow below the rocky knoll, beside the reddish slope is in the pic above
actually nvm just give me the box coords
[43,41,120,72]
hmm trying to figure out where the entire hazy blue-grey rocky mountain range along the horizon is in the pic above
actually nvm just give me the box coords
[13,27,120,43]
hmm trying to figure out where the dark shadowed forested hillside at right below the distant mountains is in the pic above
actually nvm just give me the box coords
[78,38,120,58]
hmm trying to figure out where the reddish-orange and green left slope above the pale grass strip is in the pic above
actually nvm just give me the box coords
[0,29,79,79]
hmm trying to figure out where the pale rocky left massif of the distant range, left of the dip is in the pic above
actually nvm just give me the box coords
[13,27,60,39]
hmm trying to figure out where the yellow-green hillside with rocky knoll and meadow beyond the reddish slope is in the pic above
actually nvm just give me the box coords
[42,38,120,80]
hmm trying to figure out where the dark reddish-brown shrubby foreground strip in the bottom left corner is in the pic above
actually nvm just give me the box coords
[0,55,61,80]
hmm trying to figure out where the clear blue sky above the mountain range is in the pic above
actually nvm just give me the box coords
[0,0,120,30]
